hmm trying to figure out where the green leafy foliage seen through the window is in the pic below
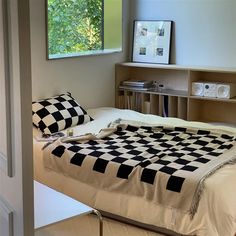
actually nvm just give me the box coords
[48,0,103,55]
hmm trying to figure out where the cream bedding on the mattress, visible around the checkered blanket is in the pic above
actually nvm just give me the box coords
[34,108,236,236]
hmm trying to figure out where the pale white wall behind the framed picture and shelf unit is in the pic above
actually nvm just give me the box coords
[132,0,236,67]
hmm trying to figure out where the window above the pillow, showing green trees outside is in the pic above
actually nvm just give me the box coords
[46,0,122,59]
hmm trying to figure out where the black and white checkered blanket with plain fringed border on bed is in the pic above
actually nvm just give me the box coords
[44,122,236,216]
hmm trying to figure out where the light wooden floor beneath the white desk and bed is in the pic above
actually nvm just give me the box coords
[35,215,164,236]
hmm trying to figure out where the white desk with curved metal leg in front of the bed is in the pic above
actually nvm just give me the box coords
[34,181,103,236]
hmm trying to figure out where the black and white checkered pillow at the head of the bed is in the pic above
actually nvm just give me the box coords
[32,93,93,134]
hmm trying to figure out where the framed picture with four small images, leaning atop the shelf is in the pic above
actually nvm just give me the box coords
[132,21,172,64]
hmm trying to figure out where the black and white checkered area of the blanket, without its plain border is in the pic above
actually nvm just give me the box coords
[52,125,236,192]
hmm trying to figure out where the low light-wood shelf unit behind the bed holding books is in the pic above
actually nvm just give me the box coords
[115,62,236,124]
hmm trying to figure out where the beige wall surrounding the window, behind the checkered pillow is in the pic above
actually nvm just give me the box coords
[30,0,132,108]
